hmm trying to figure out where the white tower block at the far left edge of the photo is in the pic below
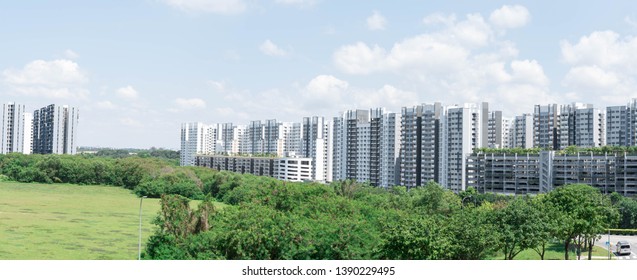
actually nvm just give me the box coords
[0,103,31,154]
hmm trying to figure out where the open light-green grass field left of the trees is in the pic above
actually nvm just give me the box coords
[0,182,221,260]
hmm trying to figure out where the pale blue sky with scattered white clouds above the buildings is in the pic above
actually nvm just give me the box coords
[0,0,637,149]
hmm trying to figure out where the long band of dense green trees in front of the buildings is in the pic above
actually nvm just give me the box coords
[0,154,637,260]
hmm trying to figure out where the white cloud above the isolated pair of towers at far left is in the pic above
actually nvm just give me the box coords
[2,59,89,99]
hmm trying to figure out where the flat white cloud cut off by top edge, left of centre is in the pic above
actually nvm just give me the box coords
[163,0,246,14]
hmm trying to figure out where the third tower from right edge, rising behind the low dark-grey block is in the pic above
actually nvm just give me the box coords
[533,104,560,150]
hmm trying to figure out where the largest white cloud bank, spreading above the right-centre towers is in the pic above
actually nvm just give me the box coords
[333,6,554,115]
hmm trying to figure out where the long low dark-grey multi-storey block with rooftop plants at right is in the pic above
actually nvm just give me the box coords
[467,151,637,196]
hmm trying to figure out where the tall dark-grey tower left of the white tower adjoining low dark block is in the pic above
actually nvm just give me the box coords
[399,103,443,188]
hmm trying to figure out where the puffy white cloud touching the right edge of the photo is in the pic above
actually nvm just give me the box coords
[560,30,637,105]
